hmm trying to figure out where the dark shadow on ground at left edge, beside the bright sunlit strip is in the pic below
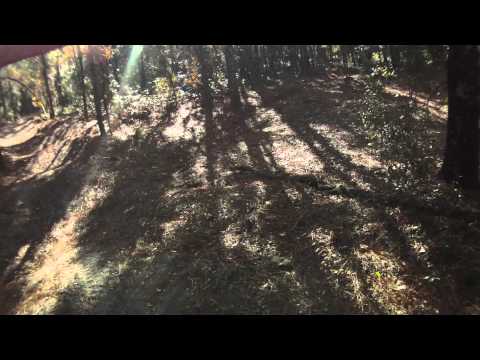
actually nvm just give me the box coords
[0,142,99,313]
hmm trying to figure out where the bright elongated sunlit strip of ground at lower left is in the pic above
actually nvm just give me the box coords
[7,137,114,314]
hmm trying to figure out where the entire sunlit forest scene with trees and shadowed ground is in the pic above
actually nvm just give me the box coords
[0,45,480,315]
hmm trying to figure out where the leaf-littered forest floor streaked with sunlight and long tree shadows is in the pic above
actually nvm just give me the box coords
[0,69,480,314]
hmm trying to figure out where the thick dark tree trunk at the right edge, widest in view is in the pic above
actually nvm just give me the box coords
[441,45,480,188]
